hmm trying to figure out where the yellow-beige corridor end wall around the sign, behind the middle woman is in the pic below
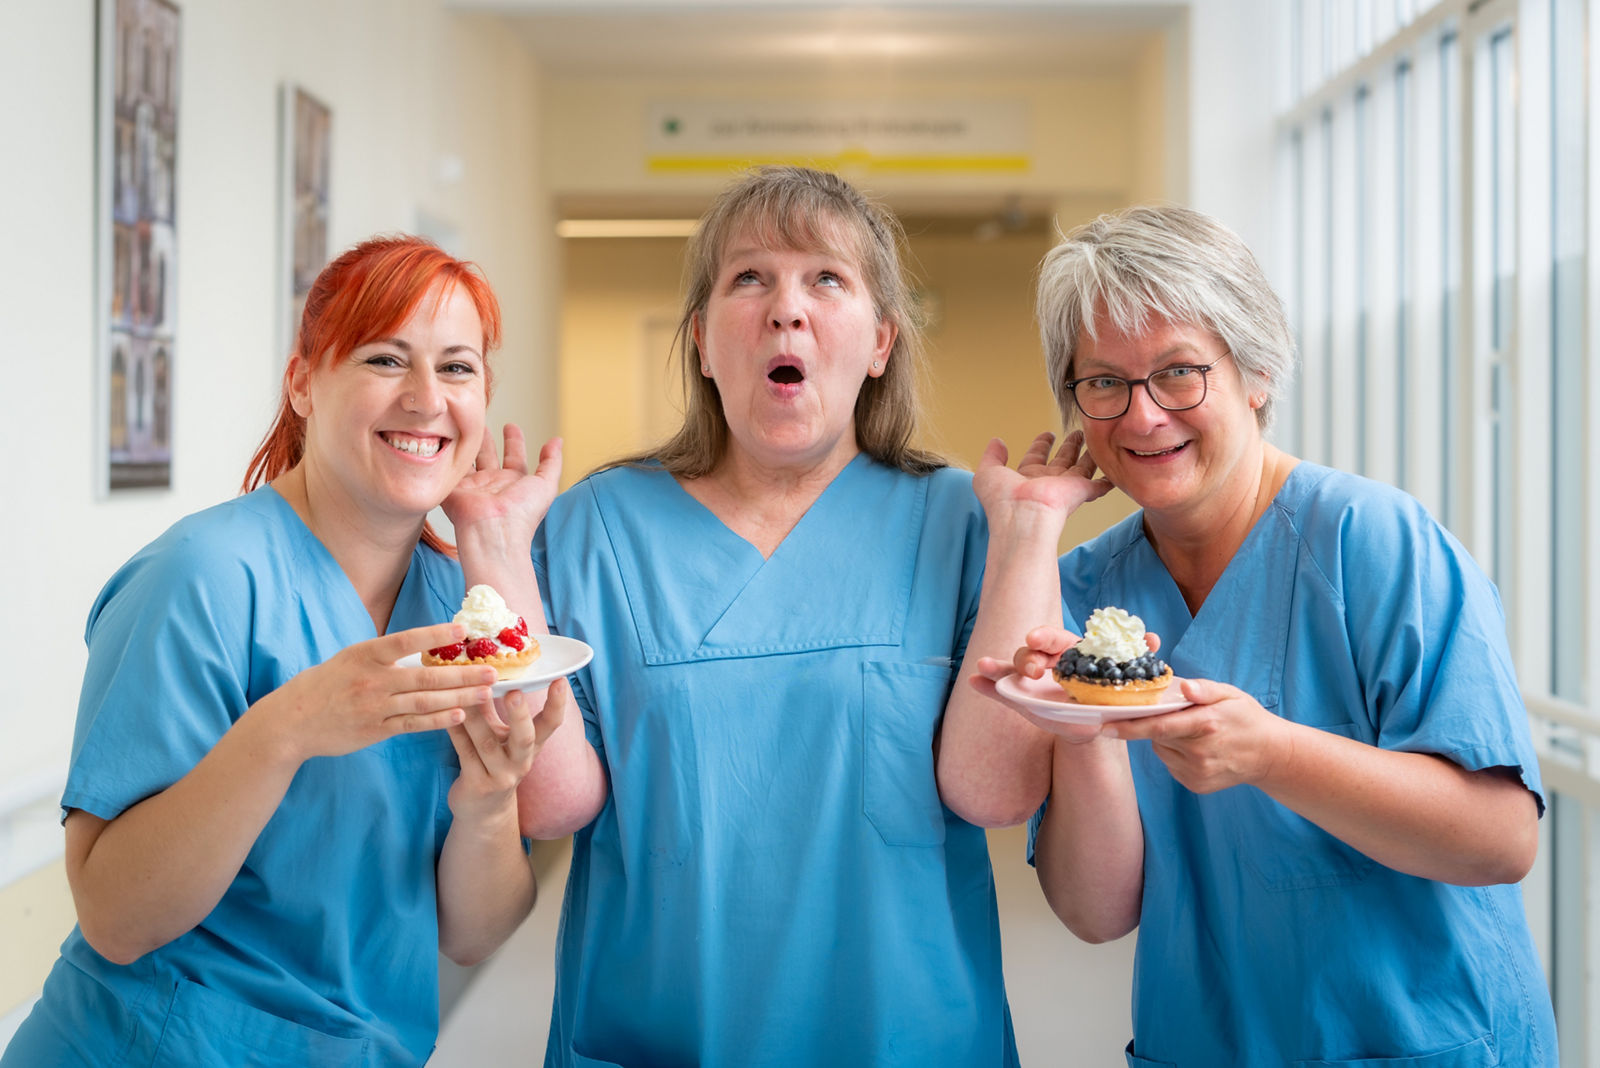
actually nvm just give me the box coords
[544,60,1152,544]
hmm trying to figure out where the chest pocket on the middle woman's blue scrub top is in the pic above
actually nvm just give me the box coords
[861,660,952,846]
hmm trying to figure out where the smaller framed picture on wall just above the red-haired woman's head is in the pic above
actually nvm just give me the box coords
[278,85,333,367]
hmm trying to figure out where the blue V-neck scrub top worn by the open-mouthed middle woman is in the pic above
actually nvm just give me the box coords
[534,456,1016,1068]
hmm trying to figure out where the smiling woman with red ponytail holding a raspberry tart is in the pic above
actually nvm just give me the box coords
[0,237,560,1068]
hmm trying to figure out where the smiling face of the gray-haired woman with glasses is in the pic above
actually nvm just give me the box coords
[1072,317,1266,521]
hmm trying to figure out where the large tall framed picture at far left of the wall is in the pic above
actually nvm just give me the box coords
[94,0,179,492]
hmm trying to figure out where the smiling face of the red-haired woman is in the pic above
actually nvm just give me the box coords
[290,286,488,524]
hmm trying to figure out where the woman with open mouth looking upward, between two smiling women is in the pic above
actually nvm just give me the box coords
[522,168,1098,1068]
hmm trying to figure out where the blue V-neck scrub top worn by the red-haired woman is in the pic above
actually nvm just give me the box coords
[0,488,462,1068]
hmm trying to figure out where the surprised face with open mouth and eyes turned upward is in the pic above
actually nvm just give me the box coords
[691,223,894,468]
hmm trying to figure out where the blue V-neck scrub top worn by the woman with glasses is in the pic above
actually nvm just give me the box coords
[1035,462,1557,1068]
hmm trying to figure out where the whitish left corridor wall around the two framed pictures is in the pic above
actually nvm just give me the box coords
[0,0,557,1015]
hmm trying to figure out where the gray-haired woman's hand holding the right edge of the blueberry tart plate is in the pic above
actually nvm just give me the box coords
[1102,679,1294,793]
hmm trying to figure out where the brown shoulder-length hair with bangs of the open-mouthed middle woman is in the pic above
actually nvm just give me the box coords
[600,166,947,478]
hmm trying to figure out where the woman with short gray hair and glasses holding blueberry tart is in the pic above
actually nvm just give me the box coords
[978,208,1557,1068]
